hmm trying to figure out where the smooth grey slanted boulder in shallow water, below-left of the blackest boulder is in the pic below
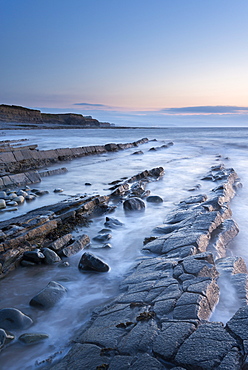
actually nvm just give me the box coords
[29,281,67,310]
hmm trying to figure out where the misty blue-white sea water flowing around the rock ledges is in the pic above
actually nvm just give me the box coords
[0,128,248,370]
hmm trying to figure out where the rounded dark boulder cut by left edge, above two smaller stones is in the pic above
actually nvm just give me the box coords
[0,308,33,330]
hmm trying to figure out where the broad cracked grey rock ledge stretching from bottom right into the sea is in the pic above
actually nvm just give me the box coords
[49,169,248,370]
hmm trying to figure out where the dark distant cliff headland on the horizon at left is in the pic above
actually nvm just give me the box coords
[0,104,112,127]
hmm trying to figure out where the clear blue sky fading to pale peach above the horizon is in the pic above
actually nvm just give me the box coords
[0,0,248,126]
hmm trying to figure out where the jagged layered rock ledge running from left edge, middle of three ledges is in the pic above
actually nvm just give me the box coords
[0,167,164,278]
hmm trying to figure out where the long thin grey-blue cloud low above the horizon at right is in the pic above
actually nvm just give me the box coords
[159,105,248,115]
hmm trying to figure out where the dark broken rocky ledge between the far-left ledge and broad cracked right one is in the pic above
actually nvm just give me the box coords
[0,167,164,279]
